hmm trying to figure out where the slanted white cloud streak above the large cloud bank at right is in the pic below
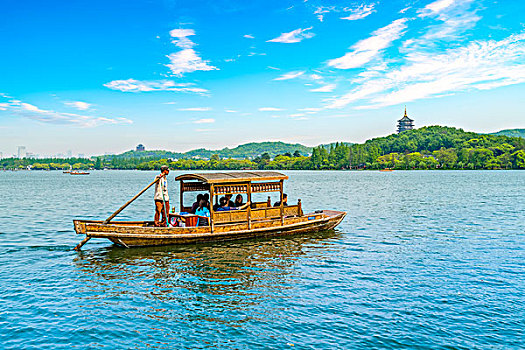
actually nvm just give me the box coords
[328,18,407,69]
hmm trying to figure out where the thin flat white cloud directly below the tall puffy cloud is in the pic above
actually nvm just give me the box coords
[104,79,208,94]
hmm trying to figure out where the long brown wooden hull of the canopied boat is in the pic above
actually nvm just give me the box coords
[74,210,346,248]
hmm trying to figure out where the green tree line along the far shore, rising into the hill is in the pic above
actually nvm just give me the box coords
[4,126,525,170]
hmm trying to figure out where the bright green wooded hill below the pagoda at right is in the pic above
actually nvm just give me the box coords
[334,126,525,169]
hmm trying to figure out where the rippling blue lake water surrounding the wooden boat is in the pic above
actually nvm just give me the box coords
[0,171,525,349]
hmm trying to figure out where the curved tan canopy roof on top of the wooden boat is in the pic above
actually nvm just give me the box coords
[175,171,288,184]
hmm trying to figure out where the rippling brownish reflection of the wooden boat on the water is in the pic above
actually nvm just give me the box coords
[71,230,341,326]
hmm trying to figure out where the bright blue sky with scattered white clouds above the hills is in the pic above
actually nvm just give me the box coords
[0,0,525,157]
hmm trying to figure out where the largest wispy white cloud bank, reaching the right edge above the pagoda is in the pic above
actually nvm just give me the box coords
[326,32,525,108]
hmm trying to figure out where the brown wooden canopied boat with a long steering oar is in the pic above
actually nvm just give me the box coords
[73,171,346,249]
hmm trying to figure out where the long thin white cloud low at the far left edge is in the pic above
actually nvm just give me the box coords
[2,99,133,127]
